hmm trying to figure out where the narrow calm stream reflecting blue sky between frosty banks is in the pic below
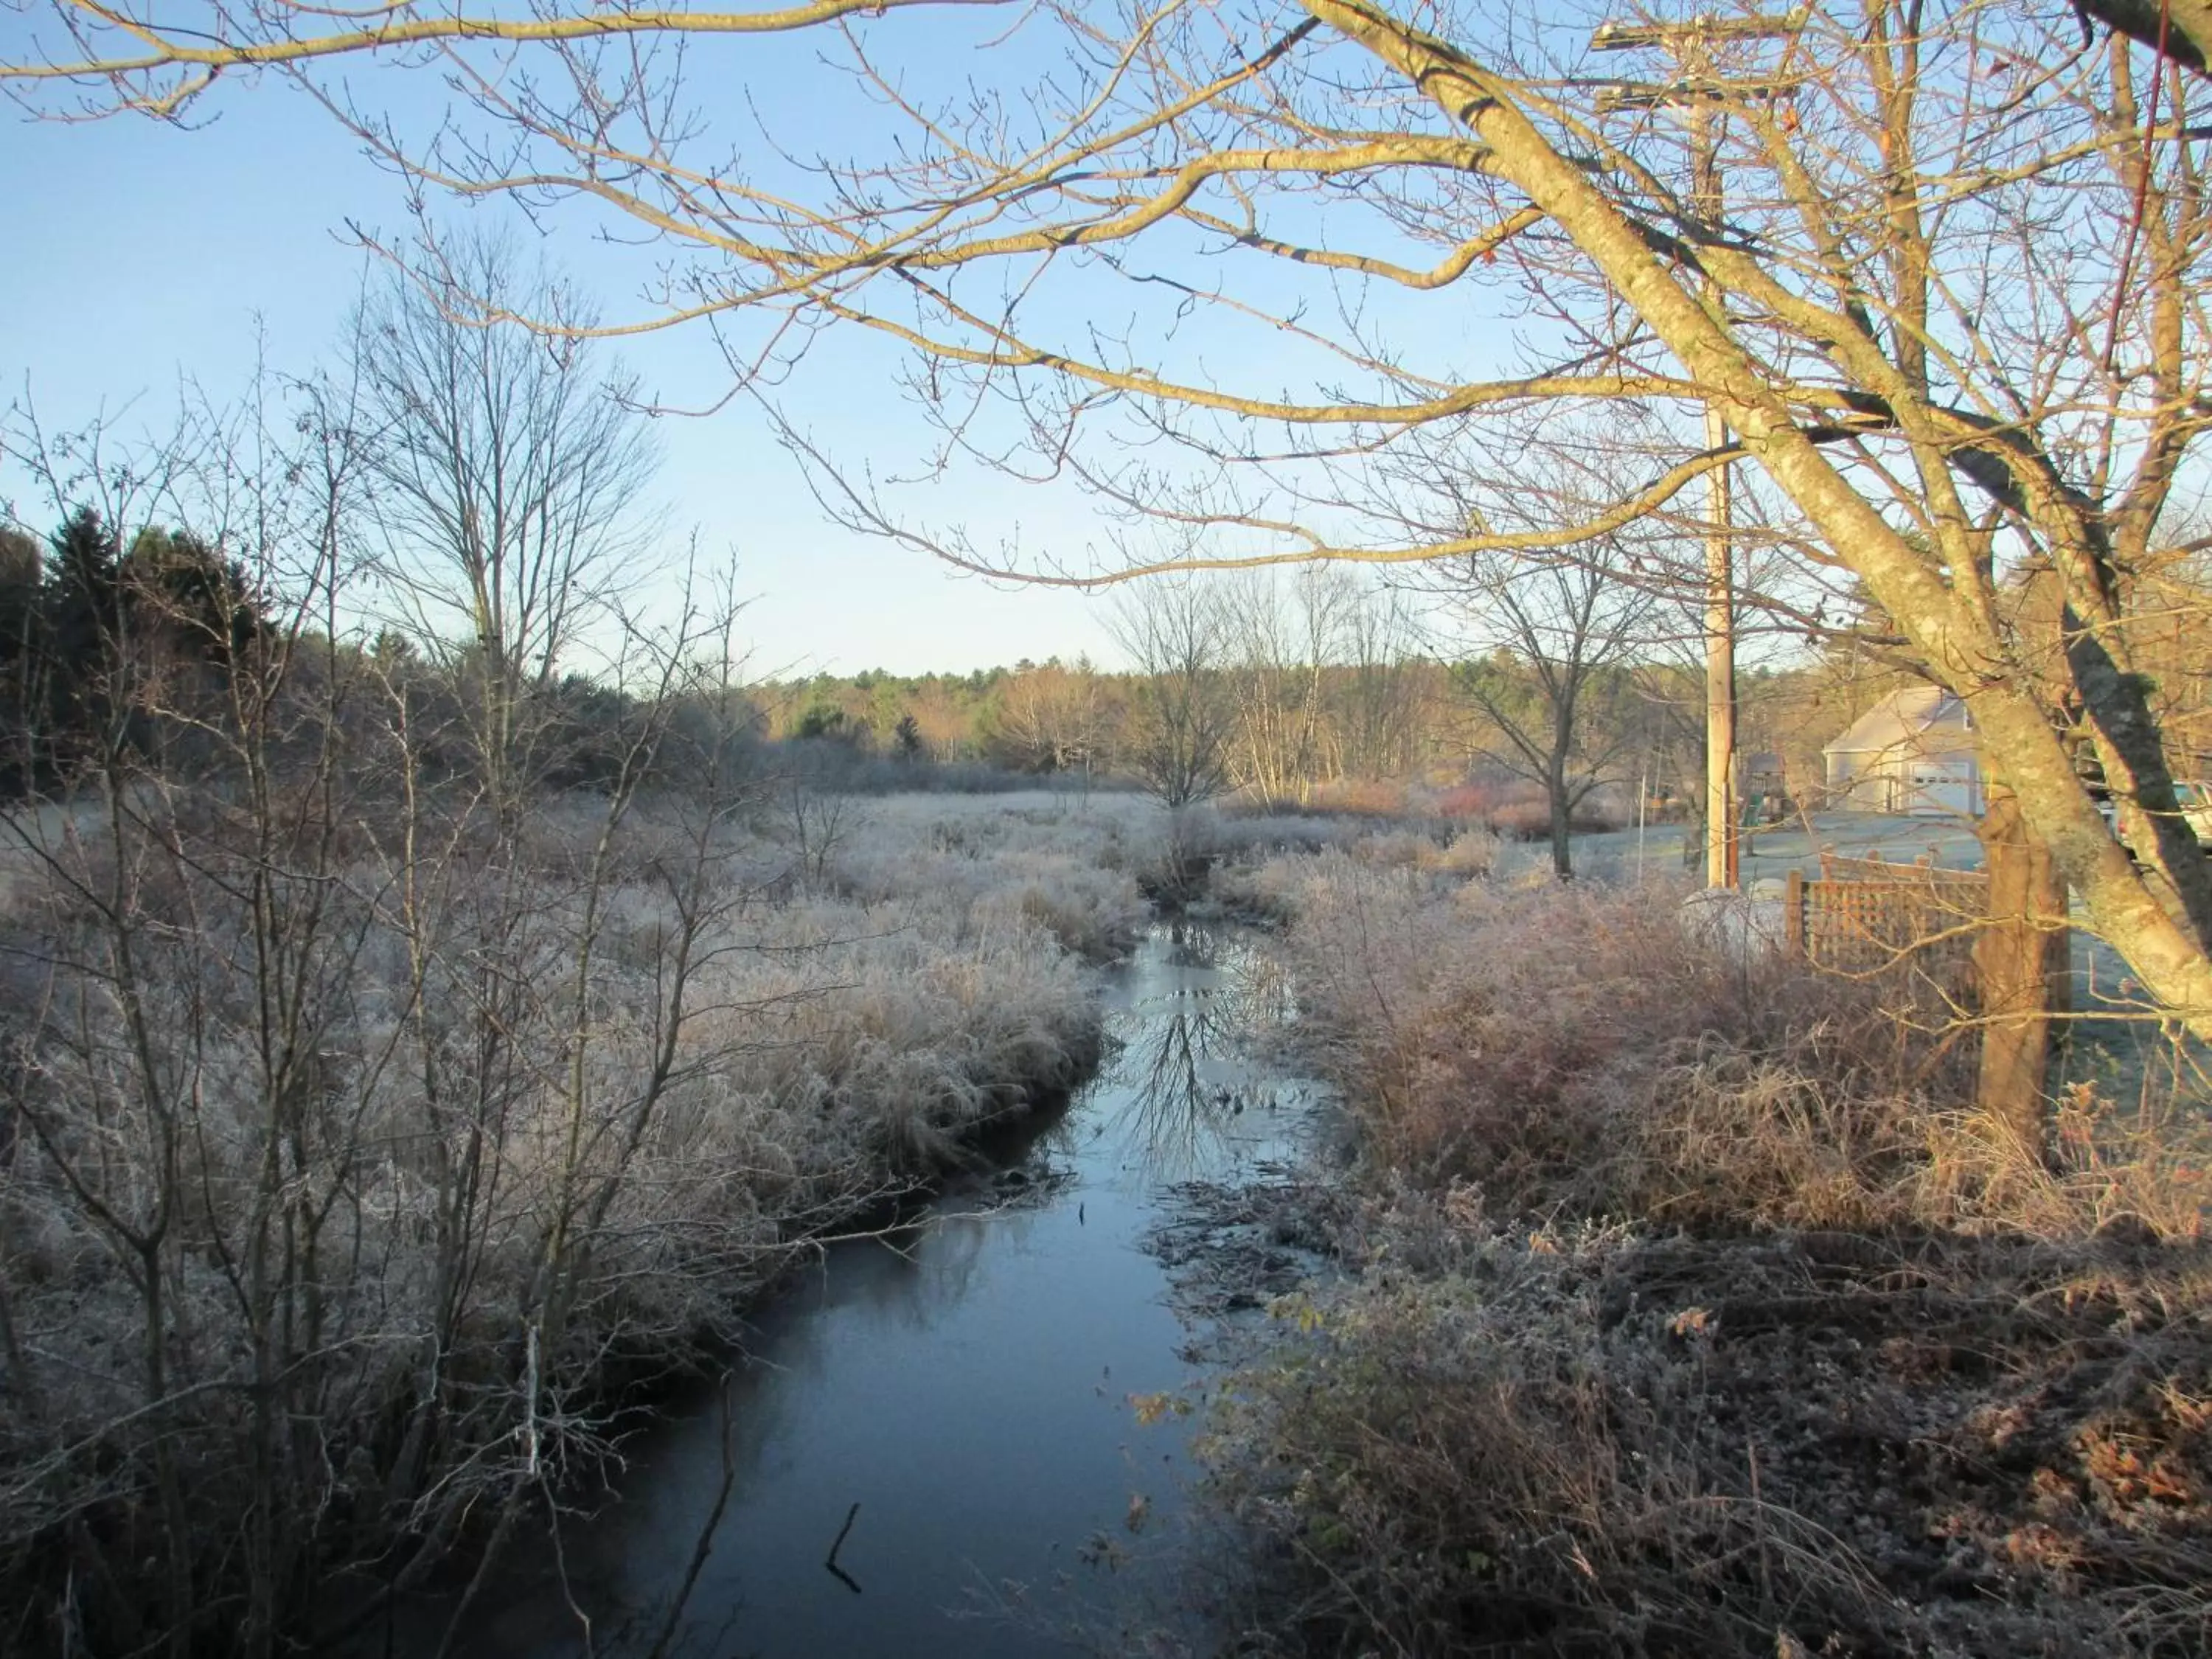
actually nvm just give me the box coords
[436,925,1321,1659]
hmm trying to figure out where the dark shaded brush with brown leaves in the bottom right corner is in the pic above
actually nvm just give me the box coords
[1210,1190,2212,1659]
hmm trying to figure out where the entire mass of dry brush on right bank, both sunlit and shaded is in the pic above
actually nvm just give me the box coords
[1212,854,2212,1657]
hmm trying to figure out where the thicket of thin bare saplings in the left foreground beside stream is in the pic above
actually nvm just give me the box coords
[0,380,770,1655]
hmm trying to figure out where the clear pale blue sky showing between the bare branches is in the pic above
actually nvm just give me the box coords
[0,7,1506,672]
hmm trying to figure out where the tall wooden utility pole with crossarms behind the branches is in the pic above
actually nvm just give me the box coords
[1590,11,1805,887]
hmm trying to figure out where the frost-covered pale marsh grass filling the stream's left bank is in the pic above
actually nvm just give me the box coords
[0,790,1157,1650]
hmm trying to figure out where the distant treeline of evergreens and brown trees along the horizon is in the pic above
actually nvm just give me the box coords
[0,507,2106,827]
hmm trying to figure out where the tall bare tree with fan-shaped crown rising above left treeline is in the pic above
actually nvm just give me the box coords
[352,237,655,814]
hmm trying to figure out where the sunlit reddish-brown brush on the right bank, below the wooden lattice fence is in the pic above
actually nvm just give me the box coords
[1270,854,2212,1237]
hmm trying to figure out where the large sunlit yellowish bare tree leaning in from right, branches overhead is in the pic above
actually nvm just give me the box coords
[21,0,2212,1035]
